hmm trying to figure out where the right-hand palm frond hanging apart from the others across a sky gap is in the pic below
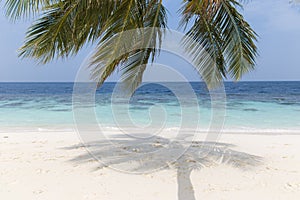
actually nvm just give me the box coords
[181,0,257,87]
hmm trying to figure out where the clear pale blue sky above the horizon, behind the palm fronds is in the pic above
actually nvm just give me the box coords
[0,0,300,82]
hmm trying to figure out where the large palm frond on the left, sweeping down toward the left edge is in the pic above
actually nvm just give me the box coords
[19,0,116,63]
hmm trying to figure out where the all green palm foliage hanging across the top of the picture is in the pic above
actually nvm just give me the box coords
[5,0,257,90]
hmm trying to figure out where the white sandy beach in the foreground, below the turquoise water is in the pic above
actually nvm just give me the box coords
[0,132,300,200]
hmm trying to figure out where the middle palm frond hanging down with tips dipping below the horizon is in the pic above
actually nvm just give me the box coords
[91,0,166,92]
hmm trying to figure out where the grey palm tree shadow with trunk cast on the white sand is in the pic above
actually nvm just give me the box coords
[66,135,262,200]
